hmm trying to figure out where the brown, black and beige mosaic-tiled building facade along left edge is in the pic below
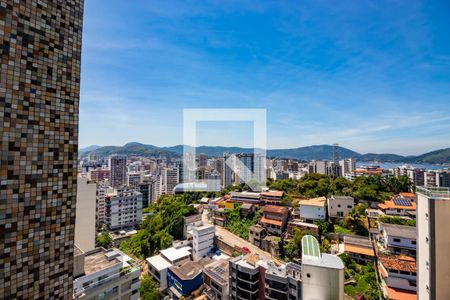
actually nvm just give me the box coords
[0,0,83,299]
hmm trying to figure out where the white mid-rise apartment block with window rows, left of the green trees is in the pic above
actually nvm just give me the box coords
[105,187,142,230]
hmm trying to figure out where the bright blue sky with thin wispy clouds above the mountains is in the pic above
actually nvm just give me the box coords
[79,0,450,154]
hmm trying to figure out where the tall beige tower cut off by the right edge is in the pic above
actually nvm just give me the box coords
[416,187,450,300]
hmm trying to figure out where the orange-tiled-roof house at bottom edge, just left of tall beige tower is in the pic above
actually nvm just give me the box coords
[378,254,417,300]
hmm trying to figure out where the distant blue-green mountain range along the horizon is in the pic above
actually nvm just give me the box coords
[79,142,450,164]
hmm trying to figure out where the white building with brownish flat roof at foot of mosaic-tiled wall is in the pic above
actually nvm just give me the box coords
[73,247,141,300]
